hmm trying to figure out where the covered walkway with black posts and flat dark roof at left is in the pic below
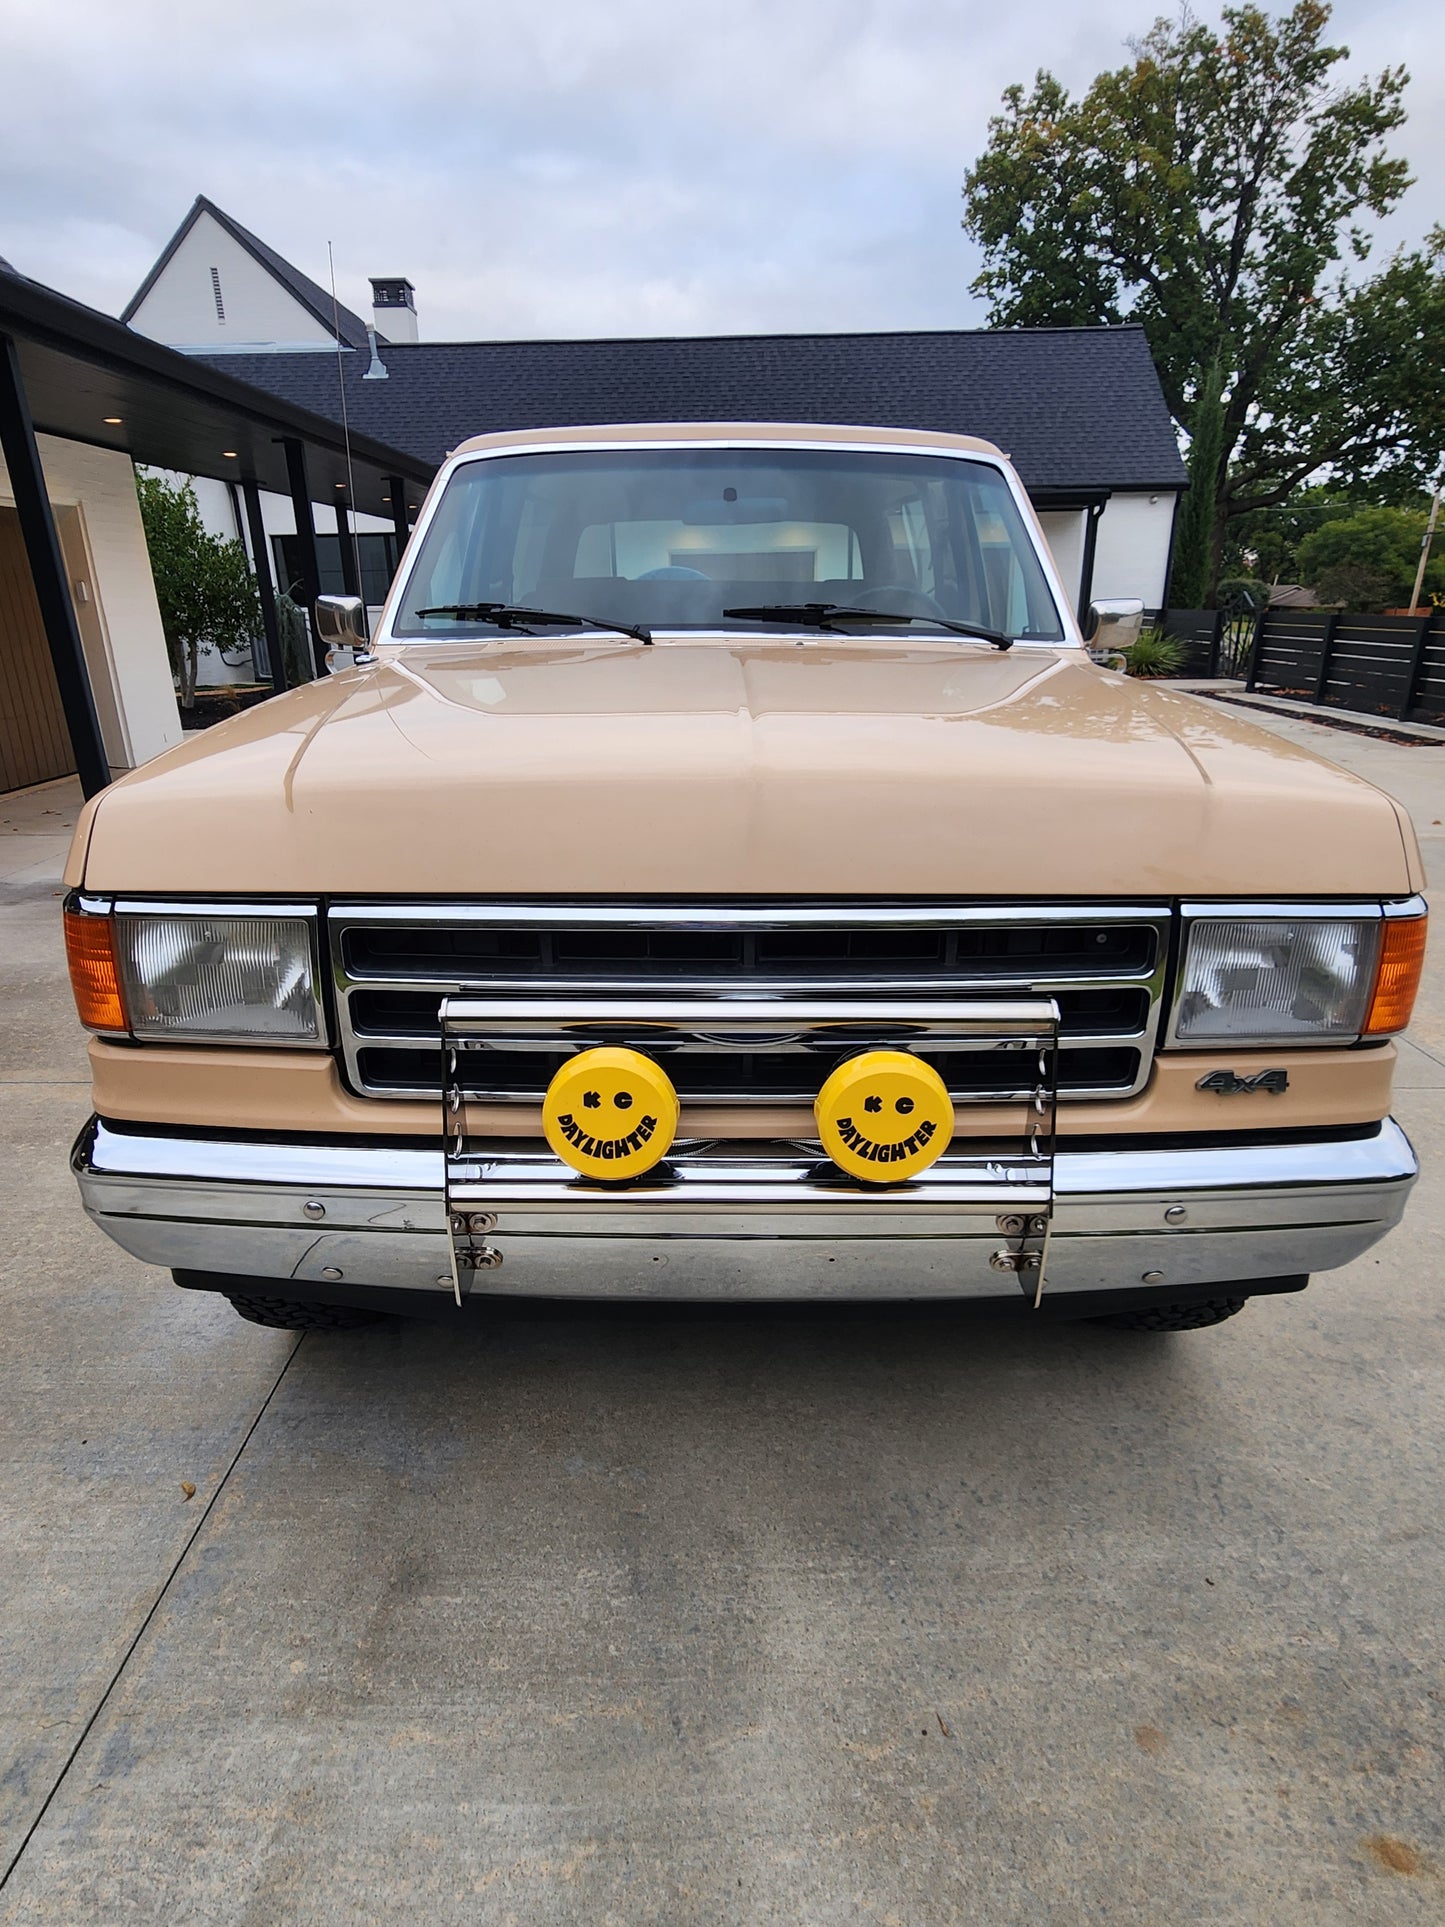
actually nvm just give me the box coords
[0,264,434,796]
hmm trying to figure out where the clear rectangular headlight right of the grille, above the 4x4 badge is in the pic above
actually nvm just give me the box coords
[1173,915,1381,1044]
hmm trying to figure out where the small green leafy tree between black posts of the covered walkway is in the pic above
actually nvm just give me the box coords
[135,474,260,709]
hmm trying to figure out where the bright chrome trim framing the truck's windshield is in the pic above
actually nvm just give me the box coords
[372,430,1085,649]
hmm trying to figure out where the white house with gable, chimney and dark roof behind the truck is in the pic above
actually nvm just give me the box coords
[123,198,1187,611]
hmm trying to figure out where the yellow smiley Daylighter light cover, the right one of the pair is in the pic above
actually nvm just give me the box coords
[813,1050,954,1185]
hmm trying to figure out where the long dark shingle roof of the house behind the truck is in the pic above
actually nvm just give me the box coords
[206,328,1185,493]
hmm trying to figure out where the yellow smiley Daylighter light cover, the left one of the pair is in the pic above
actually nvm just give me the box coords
[541,1044,678,1177]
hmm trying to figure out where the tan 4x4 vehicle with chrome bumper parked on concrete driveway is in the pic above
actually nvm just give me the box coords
[66,424,1426,1330]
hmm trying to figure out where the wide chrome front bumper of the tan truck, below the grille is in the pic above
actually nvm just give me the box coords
[71,1120,1418,1299]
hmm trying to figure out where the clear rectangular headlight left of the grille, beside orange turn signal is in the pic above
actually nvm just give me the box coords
[116,906,324,1044]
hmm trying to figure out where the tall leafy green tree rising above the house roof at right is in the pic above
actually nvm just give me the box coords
[963,0,1445,603]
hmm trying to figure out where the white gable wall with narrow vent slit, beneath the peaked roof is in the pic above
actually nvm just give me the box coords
[131,212,335,355]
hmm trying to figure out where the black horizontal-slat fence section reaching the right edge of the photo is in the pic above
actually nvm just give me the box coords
[1247,609,1445,723]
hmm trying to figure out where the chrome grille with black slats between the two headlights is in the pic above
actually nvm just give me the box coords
[328,904,1169,1104]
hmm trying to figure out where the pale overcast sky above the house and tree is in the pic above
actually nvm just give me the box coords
[0,0,1445,339]
